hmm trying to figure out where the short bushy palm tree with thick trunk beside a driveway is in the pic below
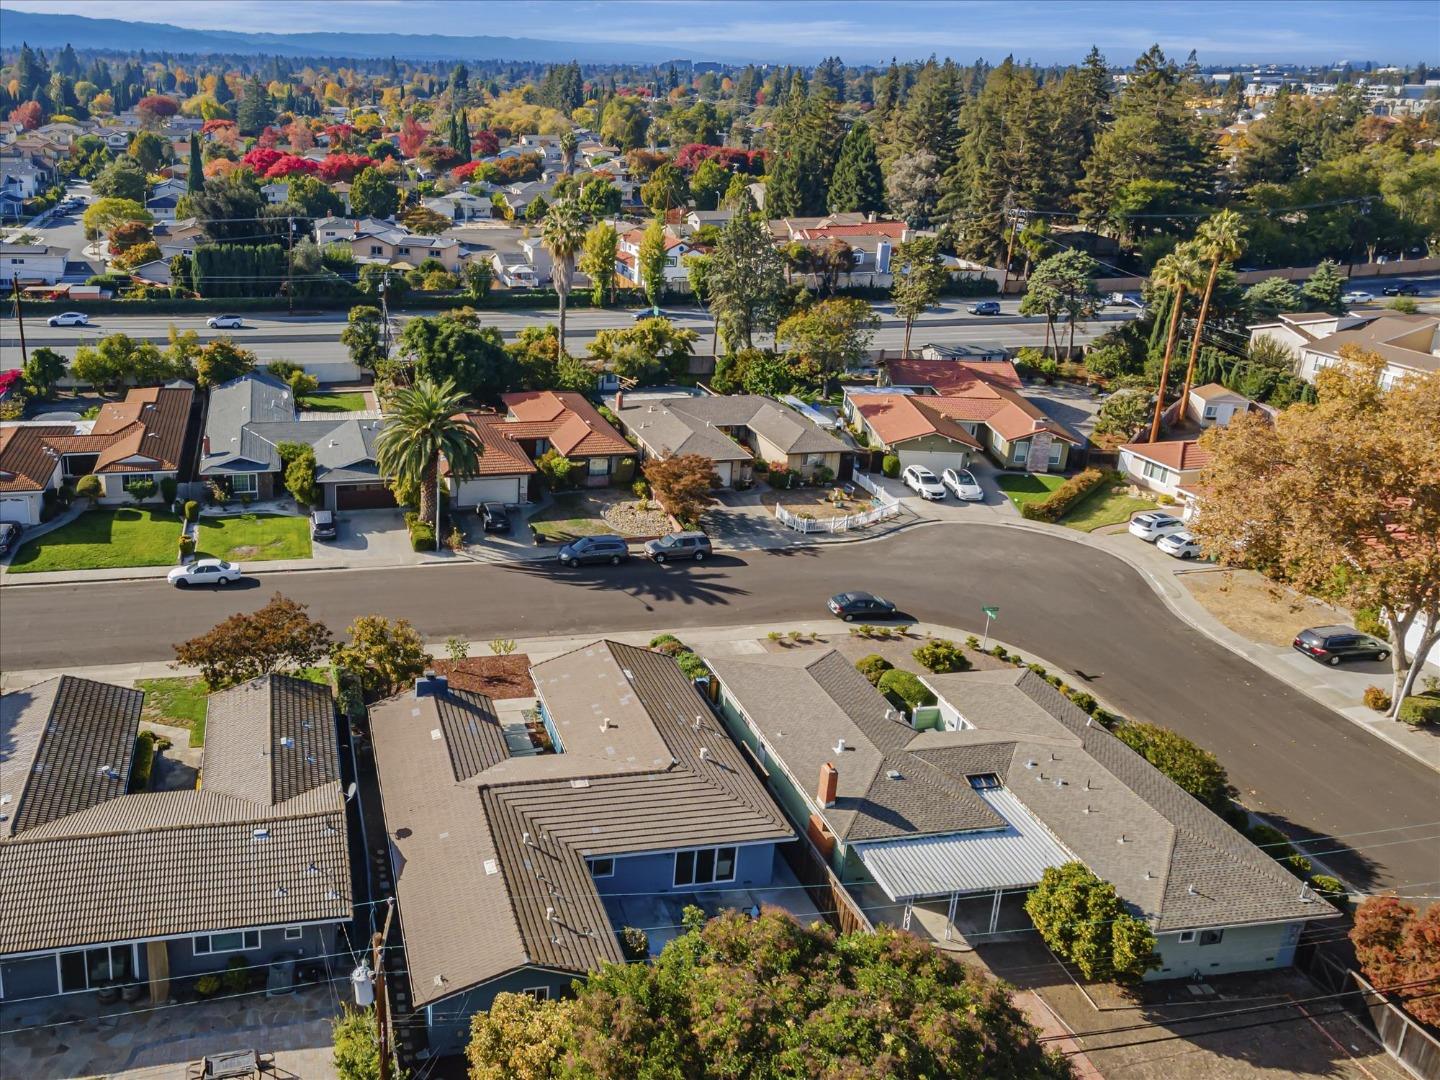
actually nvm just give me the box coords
[374,379,481,544]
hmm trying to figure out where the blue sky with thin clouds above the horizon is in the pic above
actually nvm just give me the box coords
[3,0,1440,65]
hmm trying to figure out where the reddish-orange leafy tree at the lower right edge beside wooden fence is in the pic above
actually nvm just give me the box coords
[1351,896,1440,1024]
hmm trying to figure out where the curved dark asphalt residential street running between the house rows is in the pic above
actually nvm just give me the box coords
[0,524,1440,896]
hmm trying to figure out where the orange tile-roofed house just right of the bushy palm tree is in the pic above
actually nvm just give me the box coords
[449,390,638,507]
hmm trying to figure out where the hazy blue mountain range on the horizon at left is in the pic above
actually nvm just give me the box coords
[0,4,720,63]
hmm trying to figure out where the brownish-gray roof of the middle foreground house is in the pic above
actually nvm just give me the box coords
[370,641,795,1005]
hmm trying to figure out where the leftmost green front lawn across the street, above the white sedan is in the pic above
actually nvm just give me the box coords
[10,507,182,573]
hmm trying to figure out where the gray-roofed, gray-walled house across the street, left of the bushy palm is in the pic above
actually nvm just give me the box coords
[200,373,395,510]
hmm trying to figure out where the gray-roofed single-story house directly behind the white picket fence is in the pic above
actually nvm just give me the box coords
[615,393,854,488]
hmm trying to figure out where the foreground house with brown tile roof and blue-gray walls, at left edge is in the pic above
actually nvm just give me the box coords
[0,675,353,1004]
